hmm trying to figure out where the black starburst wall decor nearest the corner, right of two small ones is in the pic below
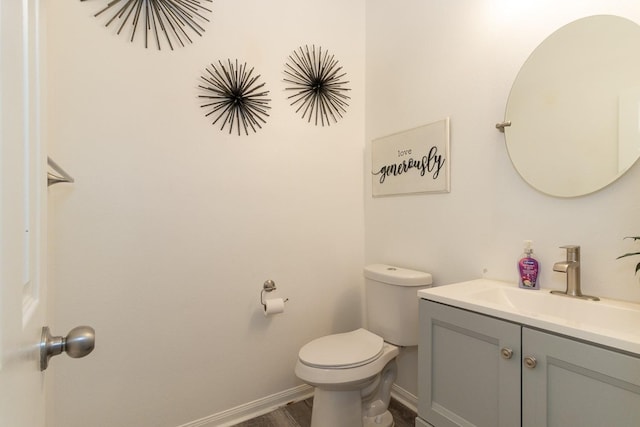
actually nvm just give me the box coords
[284,45,350,126]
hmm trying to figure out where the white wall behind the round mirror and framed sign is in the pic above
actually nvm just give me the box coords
[365,0,640,400]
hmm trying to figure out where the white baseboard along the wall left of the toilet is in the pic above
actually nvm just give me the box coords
[179,384,313,427]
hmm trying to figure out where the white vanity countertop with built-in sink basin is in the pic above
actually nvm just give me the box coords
[418,279,640,355]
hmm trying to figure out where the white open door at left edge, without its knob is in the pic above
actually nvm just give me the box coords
[0,0,46,427]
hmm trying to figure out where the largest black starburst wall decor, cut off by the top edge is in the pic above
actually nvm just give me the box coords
[80,0,213,50]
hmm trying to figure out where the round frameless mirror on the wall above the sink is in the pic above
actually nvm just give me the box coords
[504,15,640,197]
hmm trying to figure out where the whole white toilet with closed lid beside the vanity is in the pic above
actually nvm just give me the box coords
[295,264,432,427]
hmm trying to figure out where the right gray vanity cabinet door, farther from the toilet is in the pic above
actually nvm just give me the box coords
[522,327,640,427]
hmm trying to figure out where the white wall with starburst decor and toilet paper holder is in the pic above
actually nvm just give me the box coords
[47,0,365,427]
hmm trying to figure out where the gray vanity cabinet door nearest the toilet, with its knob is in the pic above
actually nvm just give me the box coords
[418,300,521,427]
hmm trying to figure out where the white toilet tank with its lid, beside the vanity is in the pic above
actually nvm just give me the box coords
[364,264,432,346]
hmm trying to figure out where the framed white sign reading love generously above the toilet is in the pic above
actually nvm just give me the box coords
[371,117,451,197]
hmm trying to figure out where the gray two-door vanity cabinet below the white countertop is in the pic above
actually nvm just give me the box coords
[416,299,640,427]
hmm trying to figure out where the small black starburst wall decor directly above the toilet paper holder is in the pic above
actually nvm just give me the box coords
[198,59,271,135]
